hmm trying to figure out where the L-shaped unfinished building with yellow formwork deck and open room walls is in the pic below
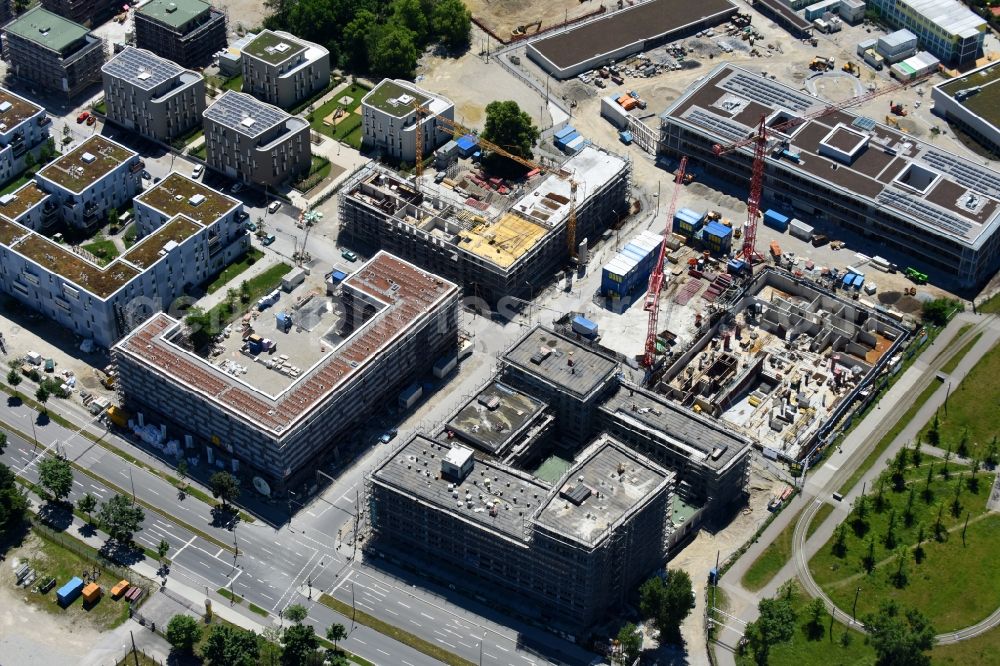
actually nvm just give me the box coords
[340,146,632,306]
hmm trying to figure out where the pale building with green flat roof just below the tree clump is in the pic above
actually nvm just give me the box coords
[241,30,330,109]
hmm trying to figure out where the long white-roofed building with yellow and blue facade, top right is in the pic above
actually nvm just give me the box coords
[868,0,989,66]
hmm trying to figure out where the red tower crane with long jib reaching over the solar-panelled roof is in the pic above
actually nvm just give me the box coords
[712,74,930,262]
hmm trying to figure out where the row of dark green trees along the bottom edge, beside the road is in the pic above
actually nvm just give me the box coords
[166,604,348,666]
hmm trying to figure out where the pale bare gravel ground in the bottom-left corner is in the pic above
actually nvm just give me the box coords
[0,537,101,666]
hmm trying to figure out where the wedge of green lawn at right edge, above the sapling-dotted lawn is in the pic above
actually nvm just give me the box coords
[921,338,1000,456]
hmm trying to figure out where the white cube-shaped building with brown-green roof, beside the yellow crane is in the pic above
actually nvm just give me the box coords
[361,79,455,164]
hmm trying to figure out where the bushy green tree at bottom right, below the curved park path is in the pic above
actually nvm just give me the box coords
[862,600,934,666]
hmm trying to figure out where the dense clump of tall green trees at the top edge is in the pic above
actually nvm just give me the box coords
[264,0,472,78]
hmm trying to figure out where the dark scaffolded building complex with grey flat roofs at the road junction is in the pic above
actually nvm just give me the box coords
[365,320,751,632]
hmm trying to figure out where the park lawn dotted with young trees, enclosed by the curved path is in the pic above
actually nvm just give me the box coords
[809,455,1000,632]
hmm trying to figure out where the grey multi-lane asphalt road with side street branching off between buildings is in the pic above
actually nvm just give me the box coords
[0,308,596,666]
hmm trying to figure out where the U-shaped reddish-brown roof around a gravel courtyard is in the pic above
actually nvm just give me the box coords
[117,252,458,437]
